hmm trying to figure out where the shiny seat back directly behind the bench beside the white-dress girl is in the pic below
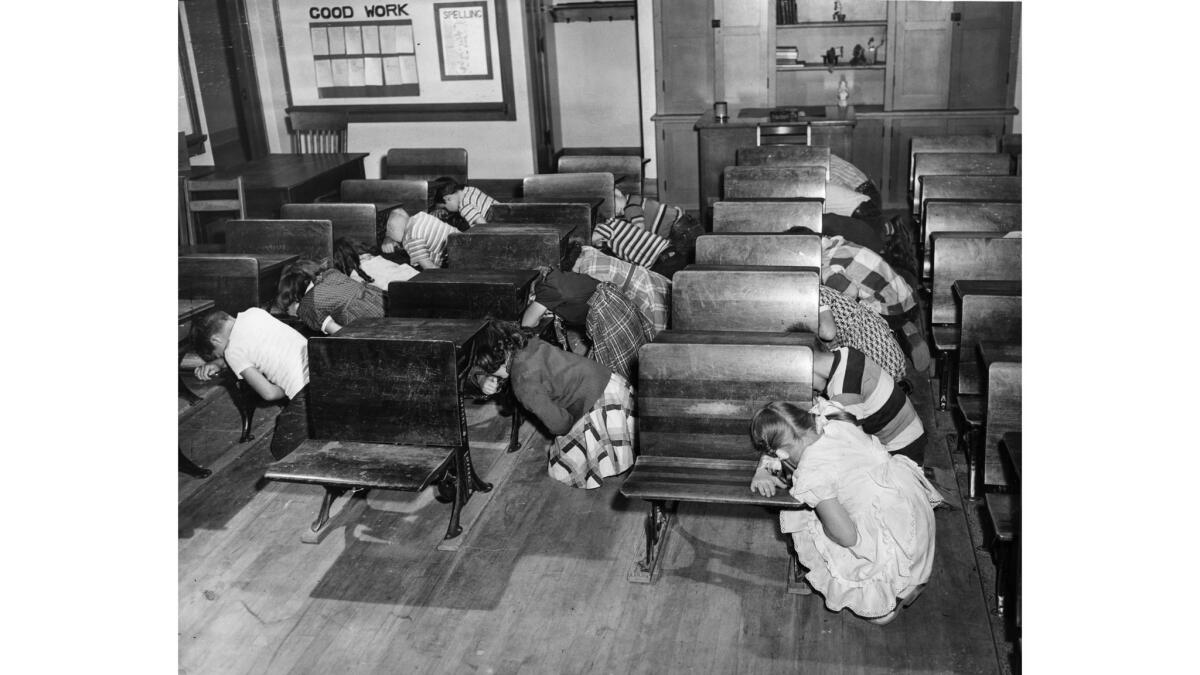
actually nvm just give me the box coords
[671,264,821,334]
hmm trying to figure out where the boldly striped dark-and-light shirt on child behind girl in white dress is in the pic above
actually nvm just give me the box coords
[826,347,925,453]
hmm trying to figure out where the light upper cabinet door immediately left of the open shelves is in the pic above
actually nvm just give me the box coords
[713,0,775,112]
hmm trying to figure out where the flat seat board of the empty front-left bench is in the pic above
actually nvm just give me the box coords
[266,438,455,491]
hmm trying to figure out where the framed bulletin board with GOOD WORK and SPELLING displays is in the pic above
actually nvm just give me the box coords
[275,0,516,121]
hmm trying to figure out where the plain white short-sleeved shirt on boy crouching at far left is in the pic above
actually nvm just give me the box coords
[224,307,308,399]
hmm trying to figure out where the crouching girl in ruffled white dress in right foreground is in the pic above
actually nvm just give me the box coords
[750,398,942,625]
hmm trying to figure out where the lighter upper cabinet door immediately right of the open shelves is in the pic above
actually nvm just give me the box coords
[888,2,954,110]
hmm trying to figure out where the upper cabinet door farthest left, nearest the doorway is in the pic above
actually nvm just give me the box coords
[654,0,713,114]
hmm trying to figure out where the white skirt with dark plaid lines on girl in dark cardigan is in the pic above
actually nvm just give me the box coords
[547,372,637,489]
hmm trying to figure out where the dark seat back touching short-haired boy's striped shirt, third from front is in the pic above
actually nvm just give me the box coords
[446,222,574,270]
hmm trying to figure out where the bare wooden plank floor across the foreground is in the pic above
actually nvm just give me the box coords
[179,367,1009,674]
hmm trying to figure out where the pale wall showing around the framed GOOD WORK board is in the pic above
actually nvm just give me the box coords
[246,0,535,178]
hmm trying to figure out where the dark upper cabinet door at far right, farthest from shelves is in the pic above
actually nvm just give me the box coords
[949,2,1016,108]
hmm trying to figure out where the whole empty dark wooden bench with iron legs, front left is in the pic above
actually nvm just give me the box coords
[265,317,492,542]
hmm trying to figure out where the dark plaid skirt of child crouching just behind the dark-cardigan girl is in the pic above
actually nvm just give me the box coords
[587,281,653,381]
